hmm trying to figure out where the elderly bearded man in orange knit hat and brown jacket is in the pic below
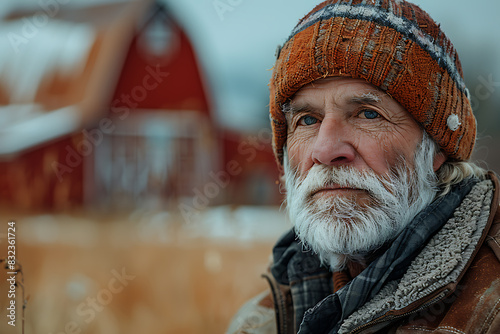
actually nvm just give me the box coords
[228,0,500,333]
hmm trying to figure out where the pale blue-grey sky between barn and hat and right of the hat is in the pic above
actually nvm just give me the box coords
[164,0,500,131]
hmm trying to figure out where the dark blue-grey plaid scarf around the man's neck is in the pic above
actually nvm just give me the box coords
[271,179,477,334]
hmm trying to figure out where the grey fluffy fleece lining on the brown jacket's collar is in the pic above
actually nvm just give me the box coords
[338,180,493,334]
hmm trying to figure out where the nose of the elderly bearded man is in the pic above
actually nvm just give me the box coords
[312,118,356,166]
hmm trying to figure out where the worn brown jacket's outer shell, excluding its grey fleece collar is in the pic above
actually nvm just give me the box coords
[228,173,500,334]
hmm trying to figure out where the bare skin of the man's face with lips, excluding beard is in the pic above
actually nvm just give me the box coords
[286,77,422,199]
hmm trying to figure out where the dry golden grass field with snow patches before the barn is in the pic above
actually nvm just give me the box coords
[0,207,287,334]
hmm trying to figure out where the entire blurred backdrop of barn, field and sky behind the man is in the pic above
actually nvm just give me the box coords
[0,0,500,334]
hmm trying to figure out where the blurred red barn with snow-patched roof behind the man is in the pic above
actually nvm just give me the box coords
[0,1,279,210]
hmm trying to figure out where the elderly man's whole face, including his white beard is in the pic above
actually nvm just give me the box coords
[285,78,442,266]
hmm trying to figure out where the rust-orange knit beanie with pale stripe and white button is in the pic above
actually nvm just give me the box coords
[270,0,476,164]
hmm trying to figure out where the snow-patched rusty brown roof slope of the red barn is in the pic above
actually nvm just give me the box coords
[0,0,151,155]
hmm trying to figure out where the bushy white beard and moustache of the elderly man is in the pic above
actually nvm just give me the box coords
[284,133,437,271]
